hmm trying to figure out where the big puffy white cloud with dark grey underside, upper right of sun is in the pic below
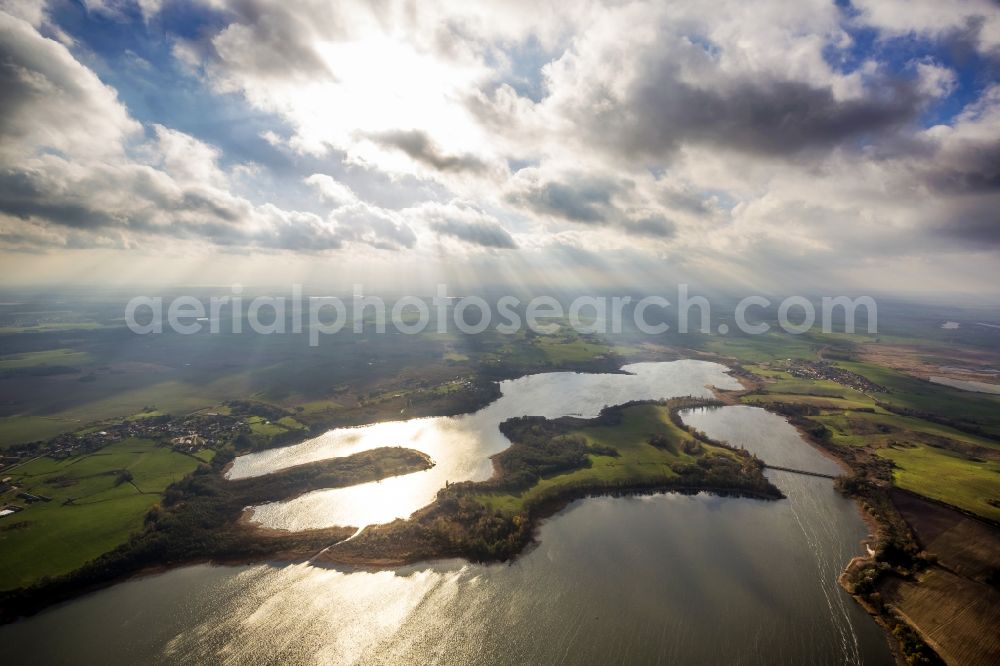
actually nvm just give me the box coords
[480,4,932,164]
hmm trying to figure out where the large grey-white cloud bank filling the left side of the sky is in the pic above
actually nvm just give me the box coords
[0,5,415,252]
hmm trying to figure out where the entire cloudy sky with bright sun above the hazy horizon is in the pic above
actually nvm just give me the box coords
[0,0,1000,294]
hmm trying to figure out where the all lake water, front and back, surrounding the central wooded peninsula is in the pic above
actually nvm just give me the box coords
[0,361,892,664]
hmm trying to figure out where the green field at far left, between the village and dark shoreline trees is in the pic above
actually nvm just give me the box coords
[0,439,205,589]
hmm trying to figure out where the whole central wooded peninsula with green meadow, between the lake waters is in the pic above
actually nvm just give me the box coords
[317,398,783,566]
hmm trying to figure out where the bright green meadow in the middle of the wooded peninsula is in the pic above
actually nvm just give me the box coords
[476,404,735,514]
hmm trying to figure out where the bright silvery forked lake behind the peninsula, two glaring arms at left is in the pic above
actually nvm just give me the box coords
[228,360,740,530]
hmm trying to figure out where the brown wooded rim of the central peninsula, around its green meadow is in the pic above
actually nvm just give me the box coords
[321,397,785,565]
